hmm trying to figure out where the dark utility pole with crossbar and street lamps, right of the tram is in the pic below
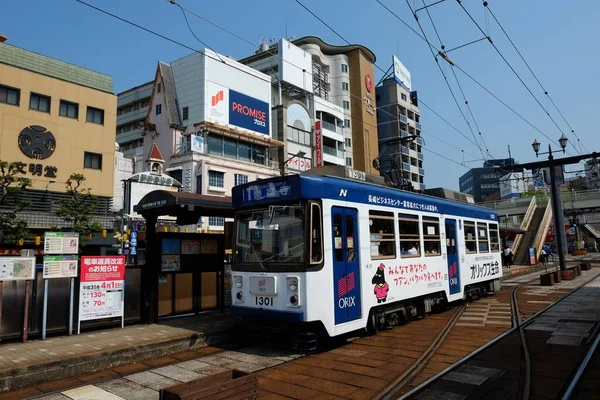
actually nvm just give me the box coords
[501,135,599,271]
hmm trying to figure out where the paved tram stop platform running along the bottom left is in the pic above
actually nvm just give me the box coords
[0,312,240,392]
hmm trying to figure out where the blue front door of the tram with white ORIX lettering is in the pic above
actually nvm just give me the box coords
[331,207,361,324]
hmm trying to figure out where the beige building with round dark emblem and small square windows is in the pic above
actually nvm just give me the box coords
[0,43,117,227]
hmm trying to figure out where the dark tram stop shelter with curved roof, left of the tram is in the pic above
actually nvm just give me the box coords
[134,190,234,324]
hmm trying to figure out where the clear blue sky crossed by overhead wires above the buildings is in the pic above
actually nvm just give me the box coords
[0,0,600,189]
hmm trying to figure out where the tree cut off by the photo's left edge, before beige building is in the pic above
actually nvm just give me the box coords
[0,160,31,244]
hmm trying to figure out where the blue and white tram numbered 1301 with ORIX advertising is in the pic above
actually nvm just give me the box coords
[232,175,502,344]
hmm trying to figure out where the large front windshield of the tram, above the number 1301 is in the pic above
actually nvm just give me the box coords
[235,205,306,266]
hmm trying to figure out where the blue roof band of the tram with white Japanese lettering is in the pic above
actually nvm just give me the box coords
[232,174,498,221]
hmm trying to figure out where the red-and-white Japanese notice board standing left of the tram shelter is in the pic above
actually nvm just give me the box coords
[79,256,125,332]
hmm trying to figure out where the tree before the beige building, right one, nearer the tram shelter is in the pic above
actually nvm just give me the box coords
[56,174,102,246]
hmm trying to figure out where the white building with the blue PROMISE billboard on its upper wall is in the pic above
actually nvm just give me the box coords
[143,50,283,231]
